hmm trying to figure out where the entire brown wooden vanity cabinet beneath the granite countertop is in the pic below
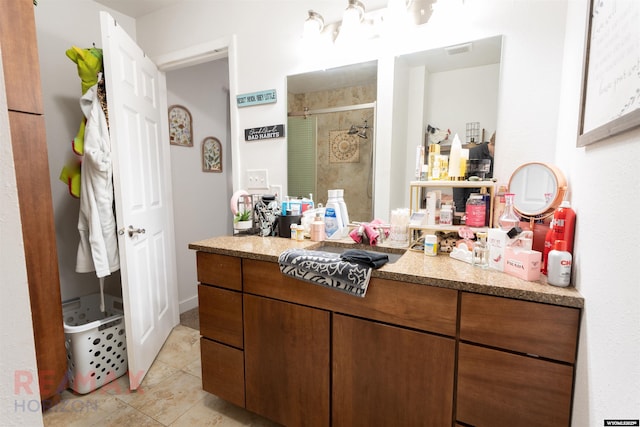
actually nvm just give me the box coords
[197,252,580,427]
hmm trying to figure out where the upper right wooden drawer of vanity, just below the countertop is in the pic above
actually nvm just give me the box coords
[460,293,580,363]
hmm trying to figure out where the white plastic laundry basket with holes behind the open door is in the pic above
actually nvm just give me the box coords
[62,294,127,394]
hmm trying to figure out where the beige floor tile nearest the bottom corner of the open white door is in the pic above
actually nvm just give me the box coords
[128,372,206,425]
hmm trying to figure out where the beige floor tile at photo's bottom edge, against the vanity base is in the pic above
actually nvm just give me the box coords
[171,394,278,427]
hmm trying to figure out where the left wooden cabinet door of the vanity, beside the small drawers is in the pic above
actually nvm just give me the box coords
[244,294,330,426]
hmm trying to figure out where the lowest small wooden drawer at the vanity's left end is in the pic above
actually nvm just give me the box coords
[200,338,245,408]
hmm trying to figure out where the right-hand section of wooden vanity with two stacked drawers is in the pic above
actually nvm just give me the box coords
[456,293,580,427]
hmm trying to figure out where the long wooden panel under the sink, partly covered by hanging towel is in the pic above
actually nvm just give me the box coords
[242,259,458,336]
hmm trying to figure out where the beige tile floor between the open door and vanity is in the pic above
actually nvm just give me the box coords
[44,316,277,427]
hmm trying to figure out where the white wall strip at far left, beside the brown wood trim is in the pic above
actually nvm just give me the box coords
[0,52,42,426]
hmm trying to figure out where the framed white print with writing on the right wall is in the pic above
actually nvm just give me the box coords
[577,0,640,147]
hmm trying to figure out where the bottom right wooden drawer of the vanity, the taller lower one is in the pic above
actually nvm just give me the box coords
[456,344,573,427]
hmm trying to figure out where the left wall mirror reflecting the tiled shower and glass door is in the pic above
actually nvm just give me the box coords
[287,61,378,221]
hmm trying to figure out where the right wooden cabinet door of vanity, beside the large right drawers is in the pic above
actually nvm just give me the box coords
[332,314,455,427]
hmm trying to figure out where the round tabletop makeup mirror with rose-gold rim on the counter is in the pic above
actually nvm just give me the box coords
[509,162,567,220]
